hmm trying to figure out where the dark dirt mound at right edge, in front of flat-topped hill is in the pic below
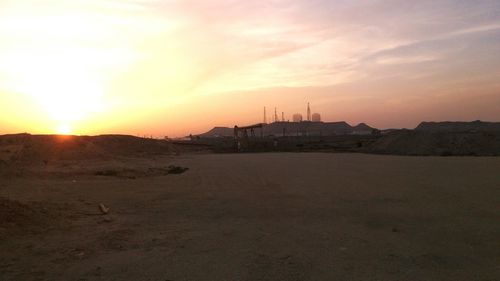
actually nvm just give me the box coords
[365,130,500,156]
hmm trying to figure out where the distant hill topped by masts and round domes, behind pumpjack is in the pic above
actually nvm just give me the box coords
[198,121,375,138]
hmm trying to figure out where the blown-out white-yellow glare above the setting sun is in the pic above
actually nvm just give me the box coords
[0,1,136,134]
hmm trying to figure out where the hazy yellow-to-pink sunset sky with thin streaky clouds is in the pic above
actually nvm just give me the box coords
[0,0,500,137]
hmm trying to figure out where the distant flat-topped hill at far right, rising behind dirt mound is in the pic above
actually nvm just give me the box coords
[415,120,500,133]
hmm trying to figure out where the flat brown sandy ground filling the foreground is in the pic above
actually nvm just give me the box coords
[0,153,500,281]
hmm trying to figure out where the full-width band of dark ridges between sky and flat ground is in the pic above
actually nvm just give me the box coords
[0,121,500,159]
